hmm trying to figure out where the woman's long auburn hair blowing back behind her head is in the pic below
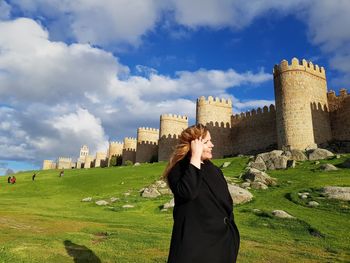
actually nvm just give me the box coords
[162,124,208,181]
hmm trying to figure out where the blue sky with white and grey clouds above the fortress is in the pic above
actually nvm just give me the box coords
[0,0,350,174]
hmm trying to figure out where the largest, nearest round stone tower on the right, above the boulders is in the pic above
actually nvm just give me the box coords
[273,58,332,150]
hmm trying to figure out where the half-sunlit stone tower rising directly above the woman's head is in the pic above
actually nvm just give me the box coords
[196,96,232,158]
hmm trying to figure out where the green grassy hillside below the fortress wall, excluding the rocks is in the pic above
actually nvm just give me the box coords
[0,155,350,263]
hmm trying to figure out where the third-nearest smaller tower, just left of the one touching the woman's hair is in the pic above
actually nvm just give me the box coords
[136,127,159,163]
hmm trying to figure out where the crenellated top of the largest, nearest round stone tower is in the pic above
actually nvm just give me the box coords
[273,58,326,79]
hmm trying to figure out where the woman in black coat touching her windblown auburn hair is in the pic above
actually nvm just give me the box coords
[163,124,240,263]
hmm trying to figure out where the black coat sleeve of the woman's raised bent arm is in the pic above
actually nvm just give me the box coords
[168,162,202,201]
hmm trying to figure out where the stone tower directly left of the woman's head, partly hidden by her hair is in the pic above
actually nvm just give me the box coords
[158,114,188,161]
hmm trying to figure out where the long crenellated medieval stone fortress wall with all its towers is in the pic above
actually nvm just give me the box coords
[43,58,350,169]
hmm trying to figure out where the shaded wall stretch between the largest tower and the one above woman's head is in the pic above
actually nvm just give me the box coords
[232,105,277,155]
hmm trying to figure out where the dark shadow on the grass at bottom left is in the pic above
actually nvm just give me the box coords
[63,240,101,263]
